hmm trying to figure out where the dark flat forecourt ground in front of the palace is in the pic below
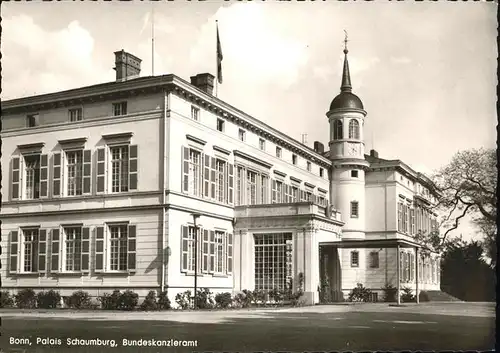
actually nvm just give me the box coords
[0,303,495,353]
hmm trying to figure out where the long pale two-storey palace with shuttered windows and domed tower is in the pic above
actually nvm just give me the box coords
[1,50,440,304]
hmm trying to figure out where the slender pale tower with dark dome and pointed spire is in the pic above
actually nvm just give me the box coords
[326,35,369,239]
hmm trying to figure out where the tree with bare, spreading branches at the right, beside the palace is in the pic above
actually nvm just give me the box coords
[432,149,498,259]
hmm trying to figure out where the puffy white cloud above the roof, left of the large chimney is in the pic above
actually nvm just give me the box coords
[2,15,114,99]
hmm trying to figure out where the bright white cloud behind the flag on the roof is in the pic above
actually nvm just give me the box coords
[190,3,309,87]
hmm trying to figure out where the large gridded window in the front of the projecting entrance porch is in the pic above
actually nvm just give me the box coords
[255,233,293,291]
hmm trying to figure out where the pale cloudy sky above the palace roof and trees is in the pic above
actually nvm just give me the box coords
[1,1,498,241]
